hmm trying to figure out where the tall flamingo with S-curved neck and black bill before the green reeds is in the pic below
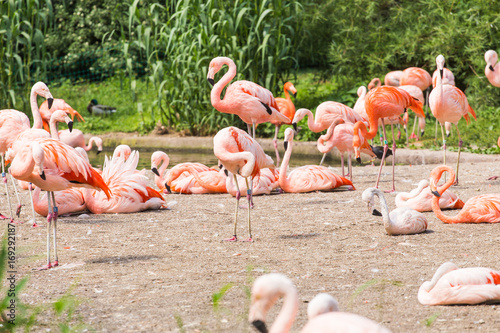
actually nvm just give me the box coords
[207,57,290,138]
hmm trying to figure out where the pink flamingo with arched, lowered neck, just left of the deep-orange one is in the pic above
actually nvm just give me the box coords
[292,102,366,133]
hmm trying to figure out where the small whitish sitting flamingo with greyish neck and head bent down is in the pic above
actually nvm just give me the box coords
[361,187,427,236]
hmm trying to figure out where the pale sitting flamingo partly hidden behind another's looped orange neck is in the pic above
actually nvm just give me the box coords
[396,179,464,212]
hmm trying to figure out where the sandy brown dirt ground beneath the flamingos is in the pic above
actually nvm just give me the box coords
[2,147,500,332]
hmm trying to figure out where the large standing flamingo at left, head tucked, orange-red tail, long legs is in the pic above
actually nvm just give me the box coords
[7,139,111,269]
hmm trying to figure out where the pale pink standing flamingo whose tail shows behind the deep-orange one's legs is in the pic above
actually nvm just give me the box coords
[317,118,376,181]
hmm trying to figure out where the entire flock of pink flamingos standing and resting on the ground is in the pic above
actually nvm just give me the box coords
[0,50,500,332]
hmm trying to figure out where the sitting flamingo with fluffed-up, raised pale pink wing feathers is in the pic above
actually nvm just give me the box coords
[83,150,165,214]
